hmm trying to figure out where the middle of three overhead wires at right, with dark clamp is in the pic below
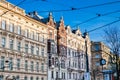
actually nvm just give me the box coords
[73,10,120,27]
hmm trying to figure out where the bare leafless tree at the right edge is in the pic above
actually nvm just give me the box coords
[104,27,120,80]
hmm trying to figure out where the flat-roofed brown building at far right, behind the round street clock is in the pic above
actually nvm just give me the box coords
[91,42,110,80]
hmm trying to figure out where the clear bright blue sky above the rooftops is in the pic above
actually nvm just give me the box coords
[7,0,120,42]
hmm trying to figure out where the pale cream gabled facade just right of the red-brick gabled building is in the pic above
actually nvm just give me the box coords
[66,26,91,80]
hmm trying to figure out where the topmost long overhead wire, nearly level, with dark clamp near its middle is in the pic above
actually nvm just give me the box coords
[38,1,120,13]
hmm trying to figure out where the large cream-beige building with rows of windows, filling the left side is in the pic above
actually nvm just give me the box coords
[0,0,48,80]
